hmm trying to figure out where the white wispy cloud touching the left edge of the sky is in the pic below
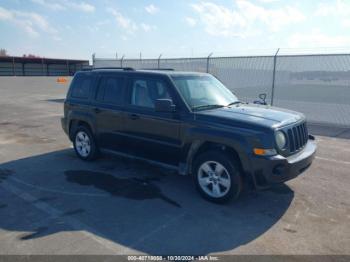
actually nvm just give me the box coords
[0,7,58,37]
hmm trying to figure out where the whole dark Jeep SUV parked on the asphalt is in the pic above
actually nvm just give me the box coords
[61,68,316,202]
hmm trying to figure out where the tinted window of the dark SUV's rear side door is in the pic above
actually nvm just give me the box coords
[96,76,124,105]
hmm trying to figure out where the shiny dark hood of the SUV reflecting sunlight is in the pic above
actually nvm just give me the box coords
[196,104,305,127]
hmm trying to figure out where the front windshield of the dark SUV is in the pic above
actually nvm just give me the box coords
[172,75,238,110]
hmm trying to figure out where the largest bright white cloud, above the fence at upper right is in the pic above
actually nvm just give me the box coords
[191,0,305,37]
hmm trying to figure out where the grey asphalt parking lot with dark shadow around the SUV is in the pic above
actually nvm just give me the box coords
[0,77,350,255]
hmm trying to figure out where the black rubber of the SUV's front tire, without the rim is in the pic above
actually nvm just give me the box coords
[192,151,242,203]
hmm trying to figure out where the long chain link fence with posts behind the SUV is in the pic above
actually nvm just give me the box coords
[93,51,350,127]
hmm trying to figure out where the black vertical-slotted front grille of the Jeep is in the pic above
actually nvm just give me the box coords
[287,122,309,153]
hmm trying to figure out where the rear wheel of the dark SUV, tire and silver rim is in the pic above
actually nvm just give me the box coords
[73,126,99,161]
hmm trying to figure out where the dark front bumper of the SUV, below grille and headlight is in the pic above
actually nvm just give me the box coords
[253,139,317,188]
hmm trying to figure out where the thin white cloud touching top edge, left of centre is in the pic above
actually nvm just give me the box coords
[31,0,95,13]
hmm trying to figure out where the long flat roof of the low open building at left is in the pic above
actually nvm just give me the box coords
[0,56,89,64]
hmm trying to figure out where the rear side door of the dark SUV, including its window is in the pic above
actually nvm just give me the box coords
[93,74,125,151]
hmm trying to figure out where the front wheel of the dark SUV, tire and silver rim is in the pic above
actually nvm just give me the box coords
[192,150,242,203]
